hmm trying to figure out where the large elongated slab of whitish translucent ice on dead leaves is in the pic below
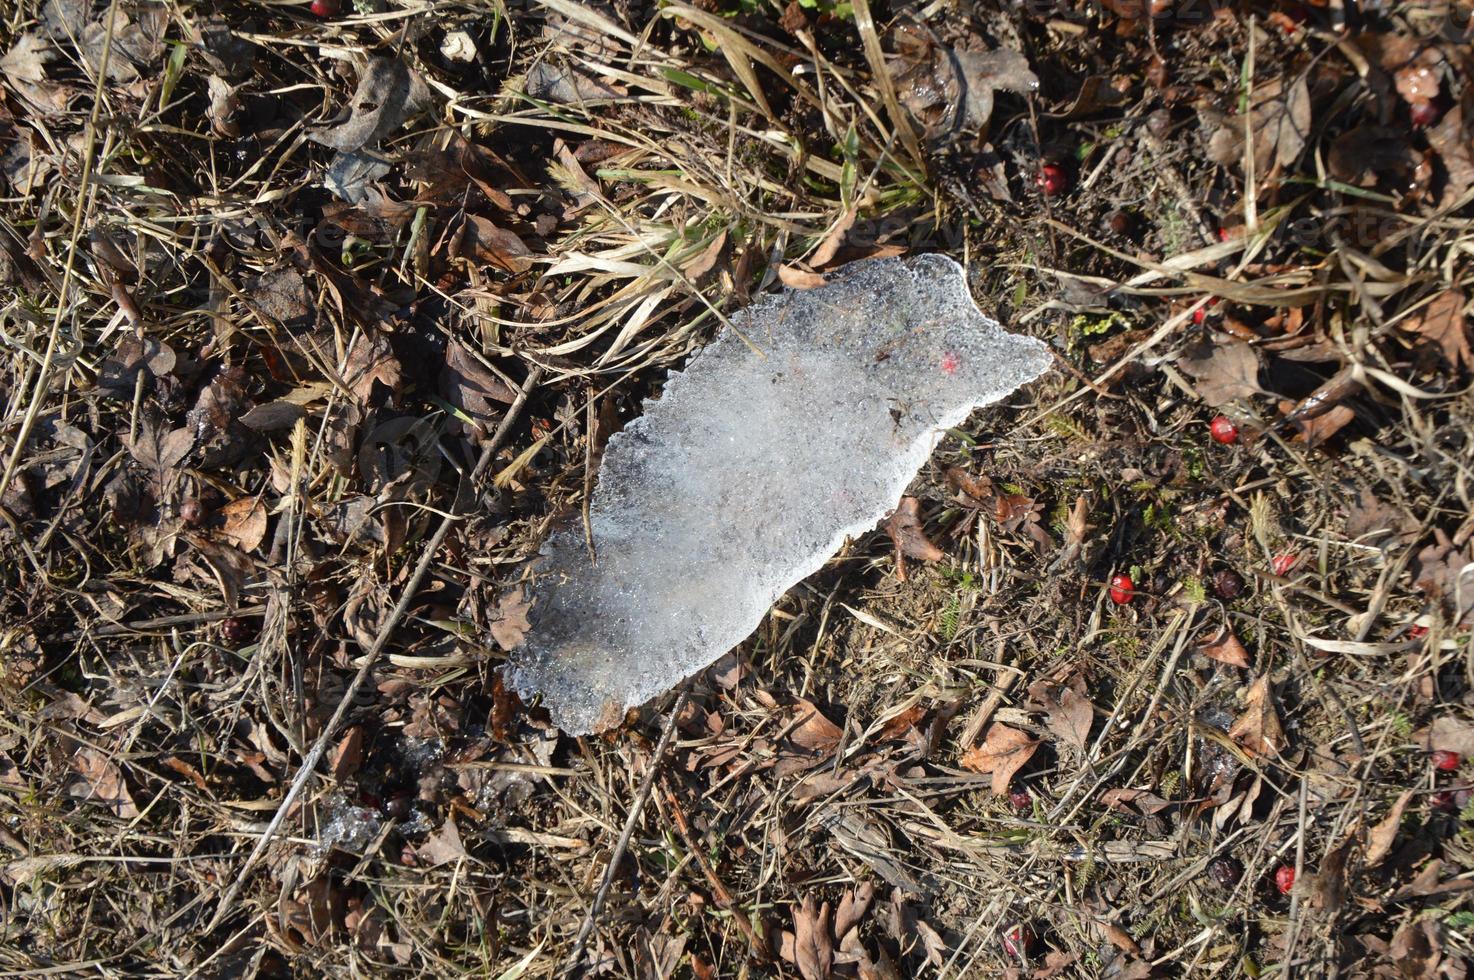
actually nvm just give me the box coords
[507,255,1051,734]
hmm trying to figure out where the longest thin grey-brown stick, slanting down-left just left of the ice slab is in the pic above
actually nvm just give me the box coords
[205,367,542,933]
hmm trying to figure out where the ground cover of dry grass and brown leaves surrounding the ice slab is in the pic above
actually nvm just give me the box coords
[0,0,1474,977]
